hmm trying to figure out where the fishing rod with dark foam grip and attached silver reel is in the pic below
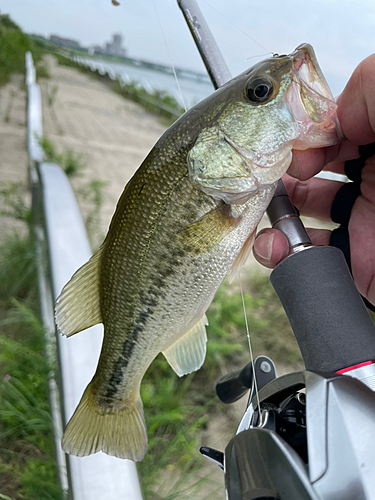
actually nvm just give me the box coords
[177,0,375,500]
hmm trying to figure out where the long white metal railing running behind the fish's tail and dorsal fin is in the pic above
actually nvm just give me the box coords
[26,53,142,500]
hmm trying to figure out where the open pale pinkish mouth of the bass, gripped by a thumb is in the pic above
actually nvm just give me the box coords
[286,43,344,149]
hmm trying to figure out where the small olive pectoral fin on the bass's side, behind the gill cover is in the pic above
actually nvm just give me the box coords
[178,202,241,253]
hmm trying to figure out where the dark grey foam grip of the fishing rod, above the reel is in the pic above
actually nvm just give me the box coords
[271,247,375,372]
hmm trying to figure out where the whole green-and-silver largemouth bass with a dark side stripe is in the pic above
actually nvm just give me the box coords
[56,44,342,461]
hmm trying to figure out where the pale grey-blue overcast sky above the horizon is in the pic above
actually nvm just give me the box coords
[0,0,375,95]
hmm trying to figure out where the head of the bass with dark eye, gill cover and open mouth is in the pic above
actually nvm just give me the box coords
[188,44,343,204]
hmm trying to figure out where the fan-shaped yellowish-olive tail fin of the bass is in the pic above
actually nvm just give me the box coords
[62,383,147,462]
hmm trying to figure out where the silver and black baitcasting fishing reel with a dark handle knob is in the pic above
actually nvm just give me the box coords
[200,356,375,500]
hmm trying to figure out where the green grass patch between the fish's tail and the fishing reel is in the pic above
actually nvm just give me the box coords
[139,274,301,500]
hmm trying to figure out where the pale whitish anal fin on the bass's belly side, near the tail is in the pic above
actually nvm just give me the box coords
[163,315,208,377]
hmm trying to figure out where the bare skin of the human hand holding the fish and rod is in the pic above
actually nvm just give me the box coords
[254,54,375,304]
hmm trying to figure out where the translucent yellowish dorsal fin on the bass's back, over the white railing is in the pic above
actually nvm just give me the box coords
[55,248,102,337]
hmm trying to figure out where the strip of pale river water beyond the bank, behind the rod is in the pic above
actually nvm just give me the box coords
[85,59,213,108]
